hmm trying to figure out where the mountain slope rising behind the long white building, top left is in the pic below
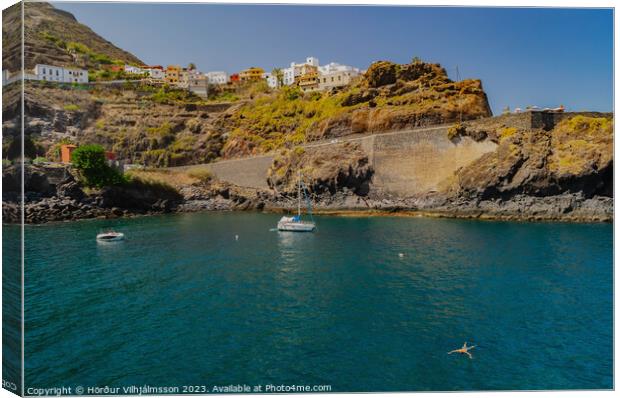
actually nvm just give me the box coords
[2,2,142,72]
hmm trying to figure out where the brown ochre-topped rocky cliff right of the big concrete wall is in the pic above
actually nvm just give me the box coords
[449,115,613,200]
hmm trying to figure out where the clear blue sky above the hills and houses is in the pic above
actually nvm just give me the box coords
[53,2,613,114]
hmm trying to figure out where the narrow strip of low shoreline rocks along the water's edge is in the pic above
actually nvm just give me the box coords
[2,187,613,224]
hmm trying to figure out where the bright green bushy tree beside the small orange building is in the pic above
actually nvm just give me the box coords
[71,145,124,188]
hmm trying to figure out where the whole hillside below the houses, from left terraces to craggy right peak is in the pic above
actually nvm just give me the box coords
[3,57,490,166]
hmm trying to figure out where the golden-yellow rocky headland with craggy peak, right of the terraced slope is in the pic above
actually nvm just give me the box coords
[222,60,491,158]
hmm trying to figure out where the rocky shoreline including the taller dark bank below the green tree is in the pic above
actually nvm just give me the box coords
[2,162,613,224]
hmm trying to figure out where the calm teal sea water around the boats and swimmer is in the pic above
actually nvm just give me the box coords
[15,213,613,391]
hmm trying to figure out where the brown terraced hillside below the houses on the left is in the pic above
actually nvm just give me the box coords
[3,82,229,166]
